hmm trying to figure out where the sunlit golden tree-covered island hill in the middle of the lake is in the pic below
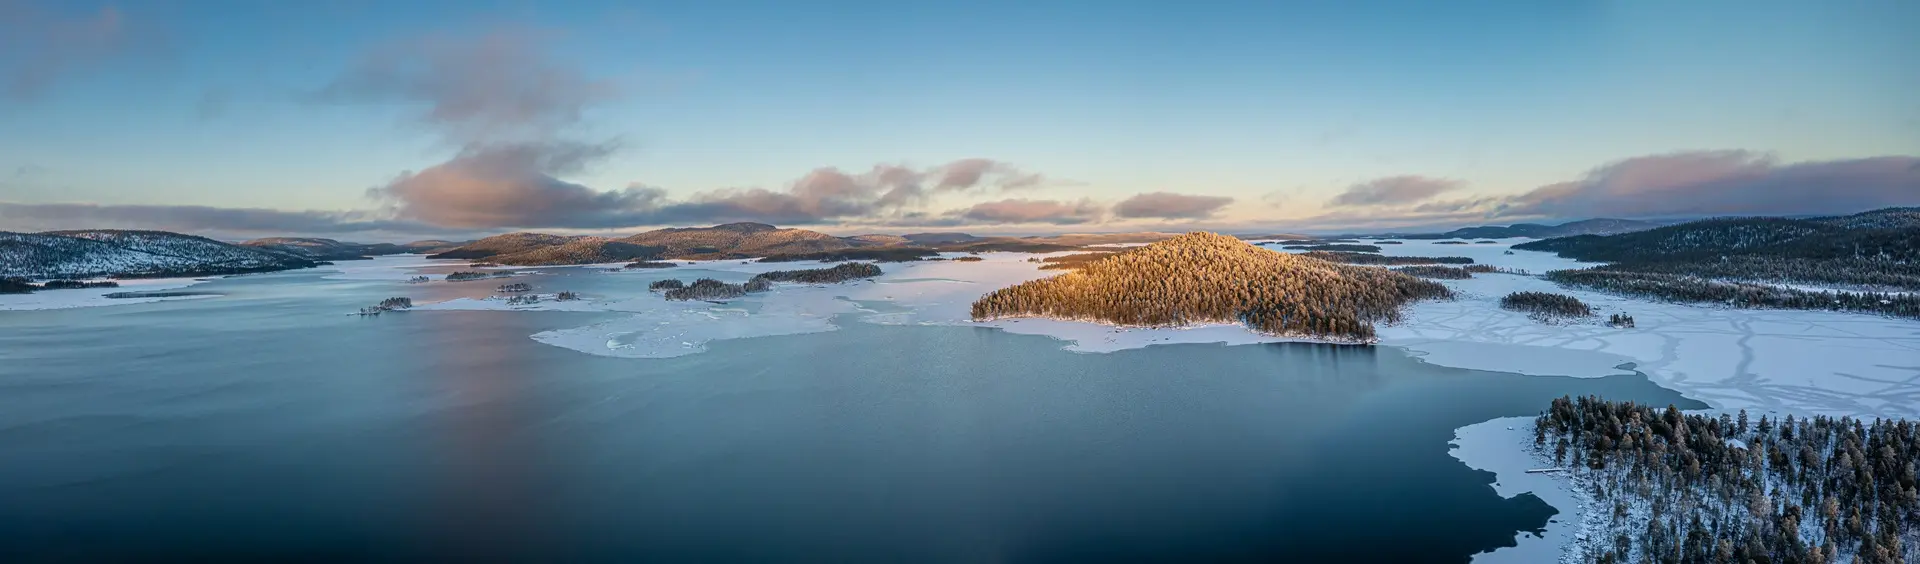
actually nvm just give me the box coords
[973,232,1452,341]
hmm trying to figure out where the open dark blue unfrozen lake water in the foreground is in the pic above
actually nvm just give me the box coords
[0,269,1697,562]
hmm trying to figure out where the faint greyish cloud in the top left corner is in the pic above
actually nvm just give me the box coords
[0,0,156,102]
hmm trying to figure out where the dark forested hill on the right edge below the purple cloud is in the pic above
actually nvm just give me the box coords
[1515,207,1920,290]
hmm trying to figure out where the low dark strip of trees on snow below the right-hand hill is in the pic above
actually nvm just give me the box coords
[1546,267,1920,318]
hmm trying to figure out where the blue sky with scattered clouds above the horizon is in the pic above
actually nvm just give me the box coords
[0,0,1920,240]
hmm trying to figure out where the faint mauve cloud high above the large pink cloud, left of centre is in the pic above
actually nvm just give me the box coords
[315,29,620,144]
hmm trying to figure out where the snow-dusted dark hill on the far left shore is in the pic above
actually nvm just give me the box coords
[0,230,321,278]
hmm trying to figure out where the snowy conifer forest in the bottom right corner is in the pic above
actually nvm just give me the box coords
[1534,397,1920,564]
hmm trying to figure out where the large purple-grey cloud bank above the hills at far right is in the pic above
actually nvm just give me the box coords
[1496,150,1920,217]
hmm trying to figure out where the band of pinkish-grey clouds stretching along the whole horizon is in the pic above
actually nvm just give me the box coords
[0,144,1920,234]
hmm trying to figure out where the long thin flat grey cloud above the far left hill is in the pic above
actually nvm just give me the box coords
[0,201,449,234]
